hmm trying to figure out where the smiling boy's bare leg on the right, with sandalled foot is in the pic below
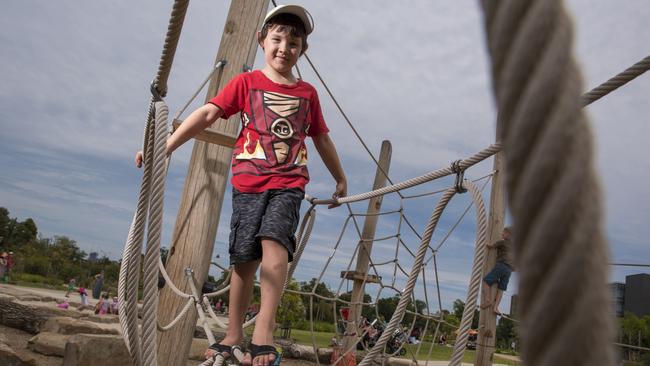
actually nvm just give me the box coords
[251,239,289,366]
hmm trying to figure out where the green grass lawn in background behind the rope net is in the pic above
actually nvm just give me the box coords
[274,329,518,366]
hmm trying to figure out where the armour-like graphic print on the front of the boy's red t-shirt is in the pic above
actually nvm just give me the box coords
[233,90,309,176]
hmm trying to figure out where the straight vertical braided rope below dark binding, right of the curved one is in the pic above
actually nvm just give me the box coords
[142,102,169,366]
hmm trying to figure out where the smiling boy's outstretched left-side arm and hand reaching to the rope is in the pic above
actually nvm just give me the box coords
[135,103,223,168]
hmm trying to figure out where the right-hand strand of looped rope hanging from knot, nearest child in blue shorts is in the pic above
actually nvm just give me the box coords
[450,180,487,366]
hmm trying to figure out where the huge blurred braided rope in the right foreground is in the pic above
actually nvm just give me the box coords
[482,0,614,366]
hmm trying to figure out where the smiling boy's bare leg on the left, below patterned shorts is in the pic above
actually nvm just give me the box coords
[220,261,259,346]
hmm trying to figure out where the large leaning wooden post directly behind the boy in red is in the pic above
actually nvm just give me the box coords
[158,0,269,366]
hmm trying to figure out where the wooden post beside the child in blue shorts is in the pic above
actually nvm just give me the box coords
[474,127,506,366]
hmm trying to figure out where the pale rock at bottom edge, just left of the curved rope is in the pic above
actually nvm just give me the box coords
[63,334,131,366]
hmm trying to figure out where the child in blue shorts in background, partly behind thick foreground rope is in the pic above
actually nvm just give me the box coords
[481,227,514,315]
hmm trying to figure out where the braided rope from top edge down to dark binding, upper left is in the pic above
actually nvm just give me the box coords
[154,0,189,97]
